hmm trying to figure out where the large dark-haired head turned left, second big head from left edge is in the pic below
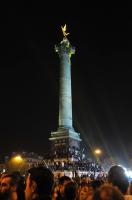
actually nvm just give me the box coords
[25,167,54,200]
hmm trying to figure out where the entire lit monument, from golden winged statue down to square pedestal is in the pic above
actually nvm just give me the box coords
[49,25,81,158]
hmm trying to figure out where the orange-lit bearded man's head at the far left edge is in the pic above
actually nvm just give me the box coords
[0,174,18,200]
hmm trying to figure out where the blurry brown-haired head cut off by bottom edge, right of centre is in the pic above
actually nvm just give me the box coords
[93,184,124,200]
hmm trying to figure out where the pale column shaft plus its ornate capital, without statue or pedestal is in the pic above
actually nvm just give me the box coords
[56,38,75,129]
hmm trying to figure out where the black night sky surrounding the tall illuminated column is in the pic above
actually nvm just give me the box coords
[0,5,132,164]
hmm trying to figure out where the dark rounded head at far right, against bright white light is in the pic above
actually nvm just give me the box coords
[108,166,129,195]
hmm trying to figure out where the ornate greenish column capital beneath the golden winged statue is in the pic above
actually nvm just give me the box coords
[55,37,75,57]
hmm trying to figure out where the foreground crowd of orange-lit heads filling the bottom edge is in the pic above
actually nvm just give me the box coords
[0,166,132,200]
